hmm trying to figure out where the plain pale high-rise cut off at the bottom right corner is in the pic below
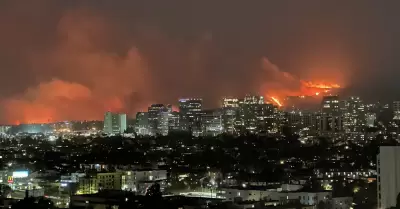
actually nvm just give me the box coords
[377,146,400,209]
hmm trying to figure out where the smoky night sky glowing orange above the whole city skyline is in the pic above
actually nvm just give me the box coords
[0,0,400,123]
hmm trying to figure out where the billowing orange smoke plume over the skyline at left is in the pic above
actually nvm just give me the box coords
[2,11,151,123]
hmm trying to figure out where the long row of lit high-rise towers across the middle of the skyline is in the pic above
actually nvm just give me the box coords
[104,95,382,136]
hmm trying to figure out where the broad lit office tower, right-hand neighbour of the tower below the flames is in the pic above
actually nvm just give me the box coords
[340,97,366,133]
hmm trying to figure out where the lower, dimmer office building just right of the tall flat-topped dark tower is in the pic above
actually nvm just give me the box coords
[201,109,223,136]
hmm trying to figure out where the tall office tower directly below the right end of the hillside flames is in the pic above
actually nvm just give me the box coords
[319,96,343,133]
